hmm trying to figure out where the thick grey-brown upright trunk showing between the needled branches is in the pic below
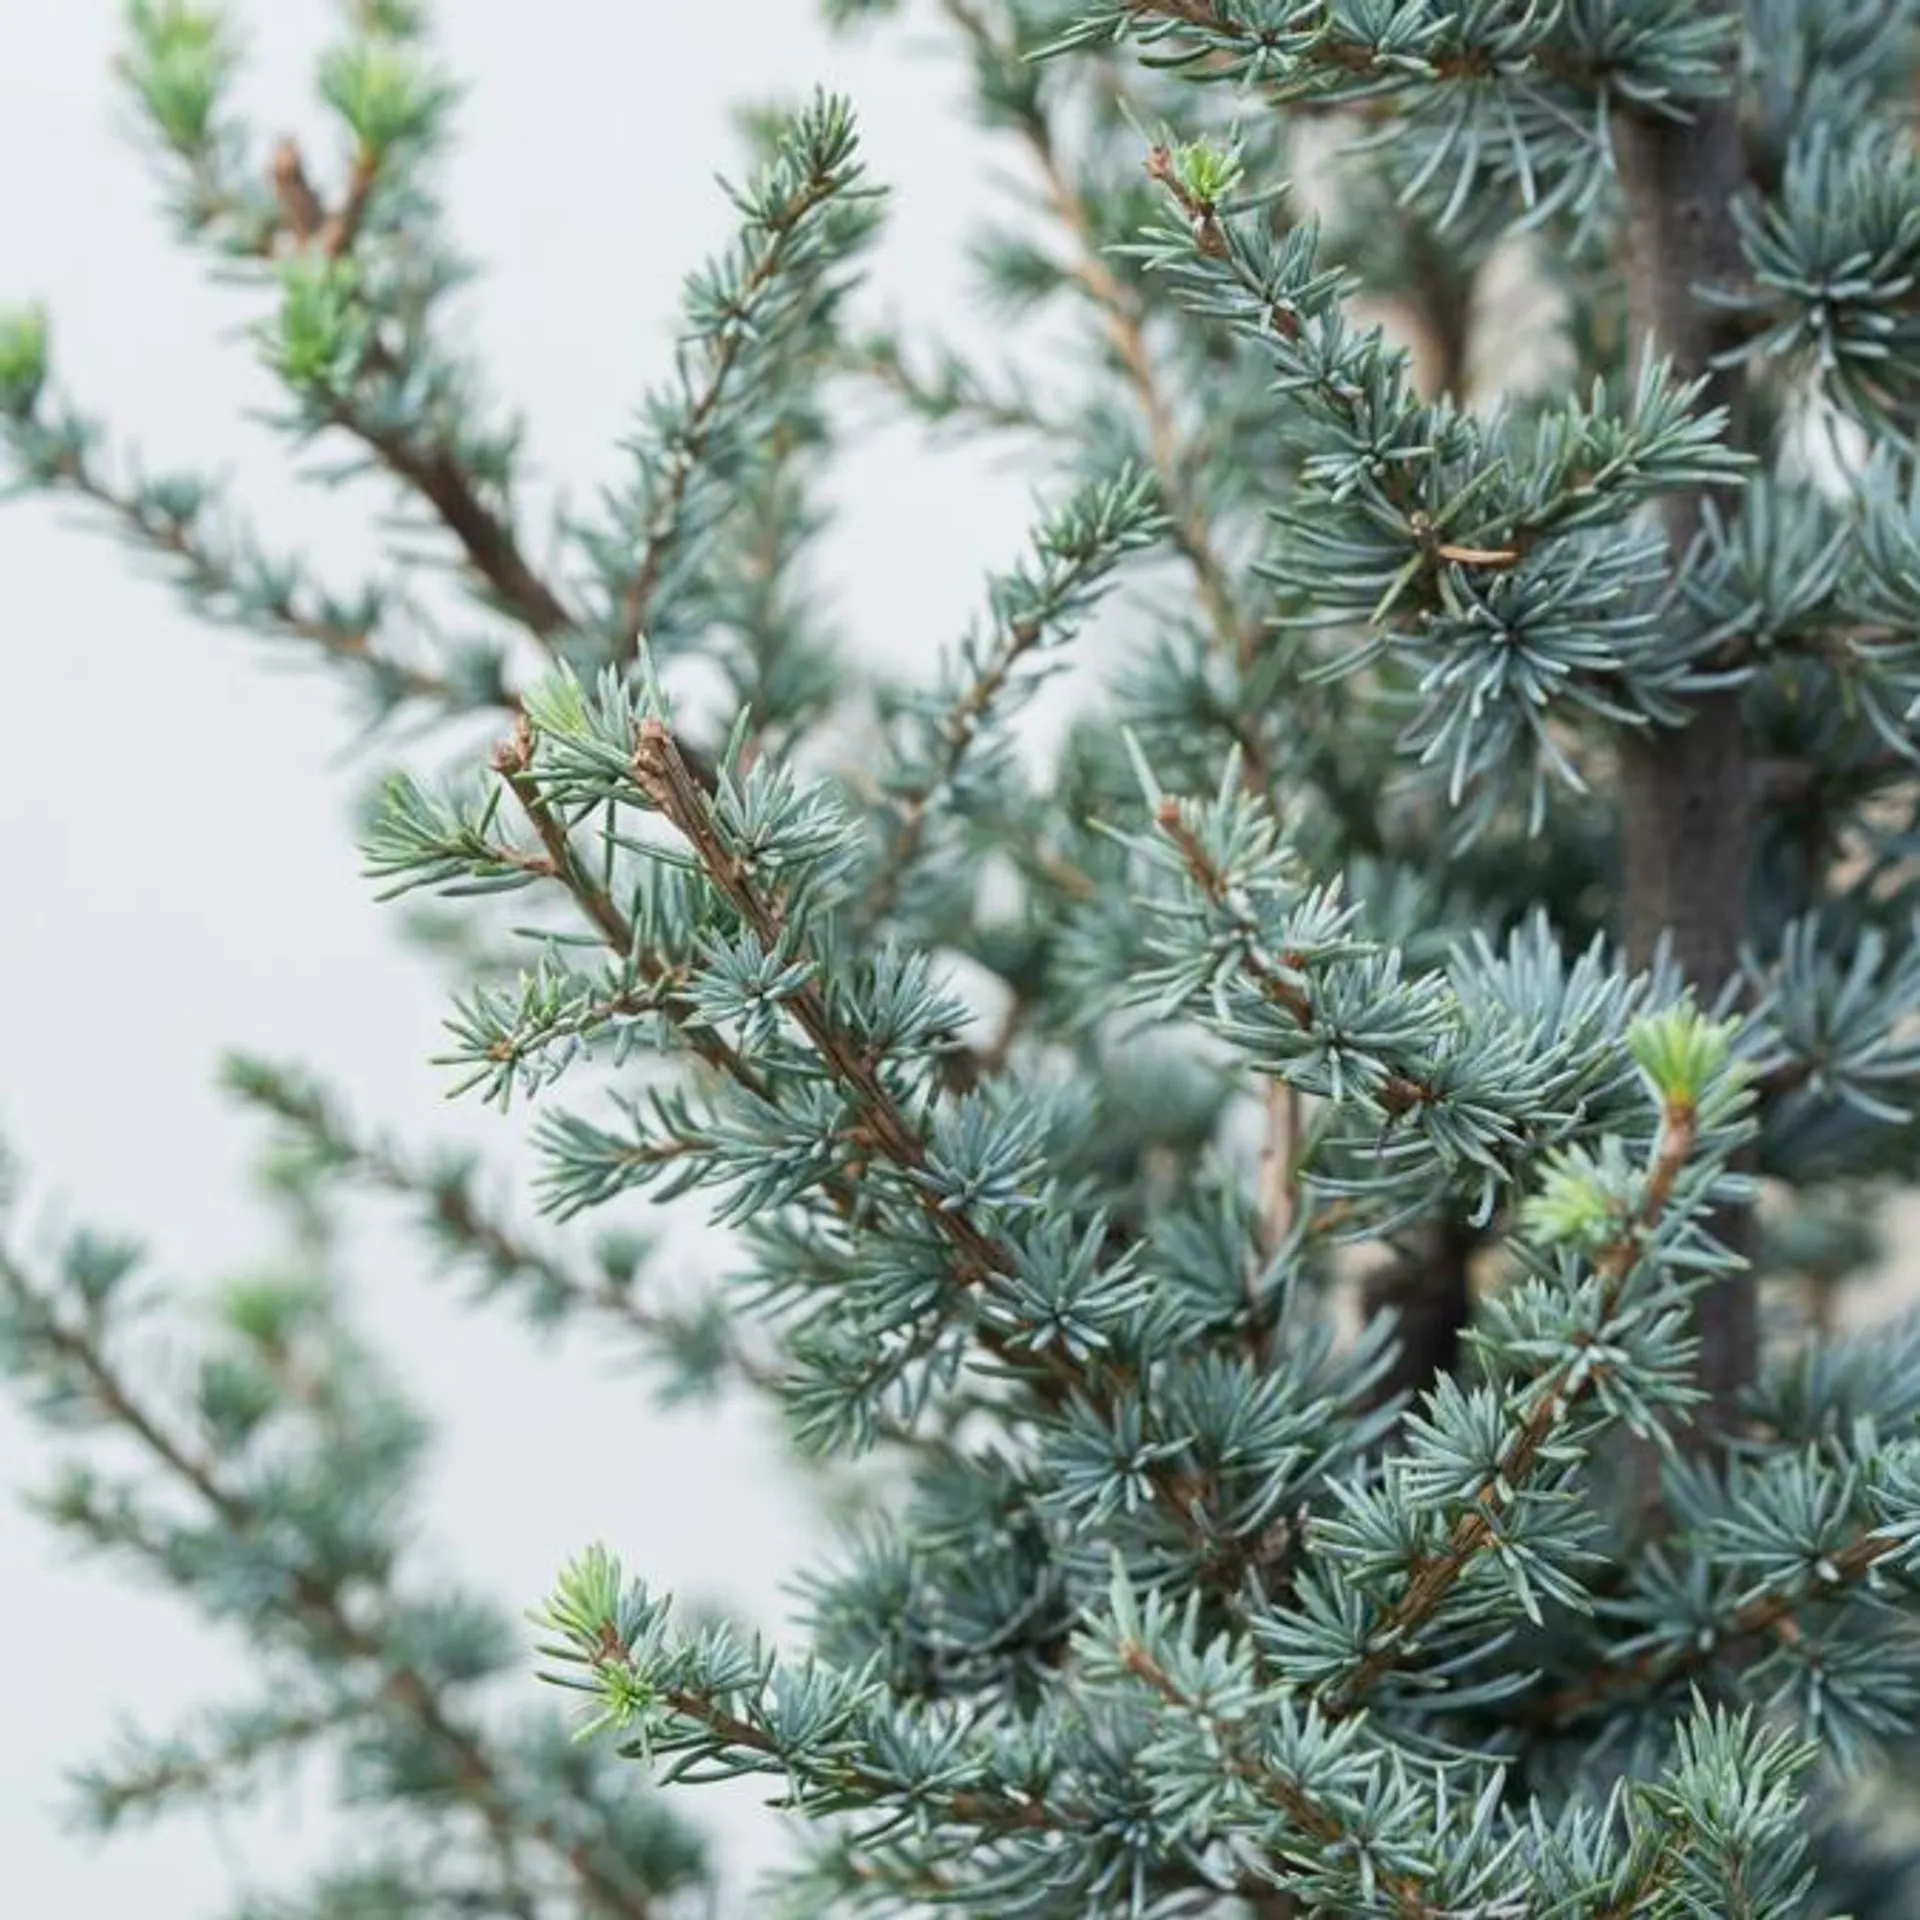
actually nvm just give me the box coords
[1613,26,1757,1430]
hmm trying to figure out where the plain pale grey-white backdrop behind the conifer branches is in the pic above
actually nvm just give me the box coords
[0,0,1029,1920]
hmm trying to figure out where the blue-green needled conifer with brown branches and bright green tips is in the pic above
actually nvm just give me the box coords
[0,0,1920,1920]
